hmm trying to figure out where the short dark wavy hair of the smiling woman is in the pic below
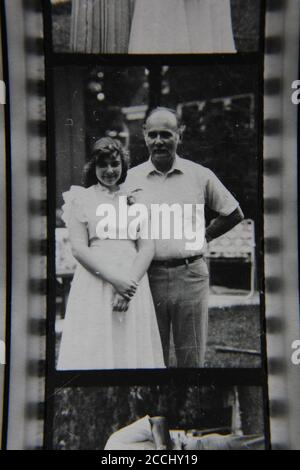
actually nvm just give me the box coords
[82,137,128,188]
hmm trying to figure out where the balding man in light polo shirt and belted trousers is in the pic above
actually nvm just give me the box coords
[126,108,243,367]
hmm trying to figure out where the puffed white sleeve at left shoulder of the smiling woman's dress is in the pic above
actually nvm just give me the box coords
[61,186,88,226]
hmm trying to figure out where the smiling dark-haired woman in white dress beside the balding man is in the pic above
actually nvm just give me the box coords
[57,138,164,370]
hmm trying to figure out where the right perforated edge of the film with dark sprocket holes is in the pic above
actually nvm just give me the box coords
[264,1,300,449]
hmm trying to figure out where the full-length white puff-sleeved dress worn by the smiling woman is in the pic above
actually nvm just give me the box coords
[57,185,164,370]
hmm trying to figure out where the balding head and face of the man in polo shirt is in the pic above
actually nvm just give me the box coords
[144,111,180,172]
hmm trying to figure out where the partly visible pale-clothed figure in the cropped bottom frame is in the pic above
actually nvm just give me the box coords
[104,415,265,450]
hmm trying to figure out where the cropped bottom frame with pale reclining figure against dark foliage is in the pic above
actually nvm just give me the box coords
[53,385,267,451]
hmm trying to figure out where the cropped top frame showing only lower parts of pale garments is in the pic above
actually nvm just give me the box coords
[52,0,261,54]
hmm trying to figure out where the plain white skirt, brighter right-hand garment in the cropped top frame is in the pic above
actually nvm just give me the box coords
[129,0,236,54]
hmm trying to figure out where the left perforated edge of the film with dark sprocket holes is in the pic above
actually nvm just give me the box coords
[1,0,47,449]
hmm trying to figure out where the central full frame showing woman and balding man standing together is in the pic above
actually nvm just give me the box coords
[50,64,263,371]
